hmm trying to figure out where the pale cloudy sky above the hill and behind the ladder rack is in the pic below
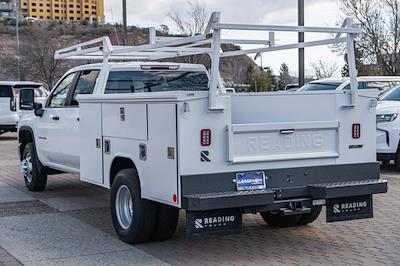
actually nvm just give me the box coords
[105,0,344,75]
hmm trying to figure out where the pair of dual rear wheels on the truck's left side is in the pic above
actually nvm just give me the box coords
[111,169,179,244]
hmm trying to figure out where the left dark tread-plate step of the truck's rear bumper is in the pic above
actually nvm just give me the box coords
[183,189,274,211]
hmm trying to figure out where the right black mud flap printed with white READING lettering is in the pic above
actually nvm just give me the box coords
[326,195,374,222]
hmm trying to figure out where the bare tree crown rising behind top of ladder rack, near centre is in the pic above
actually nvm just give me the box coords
[168,0,209,35]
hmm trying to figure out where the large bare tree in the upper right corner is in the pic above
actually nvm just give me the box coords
[340,0,400,75]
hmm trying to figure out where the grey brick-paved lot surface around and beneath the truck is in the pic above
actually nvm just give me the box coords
[0,134,400,265]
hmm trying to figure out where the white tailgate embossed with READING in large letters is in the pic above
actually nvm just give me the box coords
[227,121,339,163]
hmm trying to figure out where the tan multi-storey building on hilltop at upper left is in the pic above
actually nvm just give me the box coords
[19,0,104,23]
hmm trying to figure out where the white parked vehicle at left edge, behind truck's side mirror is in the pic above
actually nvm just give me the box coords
[0,81,48,135]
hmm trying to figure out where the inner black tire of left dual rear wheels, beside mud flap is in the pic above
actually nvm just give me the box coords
[152,203,179,241]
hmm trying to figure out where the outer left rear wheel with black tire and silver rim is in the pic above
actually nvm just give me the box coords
[111,169,156,244]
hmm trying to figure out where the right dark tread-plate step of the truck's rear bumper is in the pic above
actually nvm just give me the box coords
[307,179,387,199]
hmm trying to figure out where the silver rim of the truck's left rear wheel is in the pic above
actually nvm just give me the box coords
[115,185,133,230]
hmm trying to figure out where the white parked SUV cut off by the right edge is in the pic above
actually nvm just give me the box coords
[376,86,400,170]
